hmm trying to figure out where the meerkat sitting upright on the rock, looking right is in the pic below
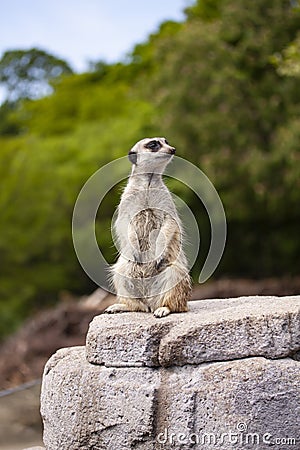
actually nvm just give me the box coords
[105,137,191,318]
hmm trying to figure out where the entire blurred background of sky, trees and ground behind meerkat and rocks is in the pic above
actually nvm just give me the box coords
[0,0,300,450]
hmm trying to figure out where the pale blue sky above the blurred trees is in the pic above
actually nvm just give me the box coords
[0,0,191,72]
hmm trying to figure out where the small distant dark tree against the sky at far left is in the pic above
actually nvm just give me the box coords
[0,48,72,103]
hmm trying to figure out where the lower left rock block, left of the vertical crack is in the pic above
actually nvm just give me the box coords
[41,347,160,450]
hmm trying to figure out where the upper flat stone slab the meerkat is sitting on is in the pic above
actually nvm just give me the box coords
[86,296,300,367]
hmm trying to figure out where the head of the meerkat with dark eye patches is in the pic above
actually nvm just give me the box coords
[128,137,175,173]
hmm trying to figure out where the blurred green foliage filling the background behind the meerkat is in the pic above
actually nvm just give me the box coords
[0,0,300,335]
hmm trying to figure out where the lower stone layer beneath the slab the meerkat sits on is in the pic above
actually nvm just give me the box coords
[42,348,300,450]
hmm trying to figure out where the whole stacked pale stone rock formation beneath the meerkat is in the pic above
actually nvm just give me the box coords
[41,297,300,450]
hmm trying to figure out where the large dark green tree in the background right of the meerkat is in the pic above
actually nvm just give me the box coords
[144,0,300,277]
